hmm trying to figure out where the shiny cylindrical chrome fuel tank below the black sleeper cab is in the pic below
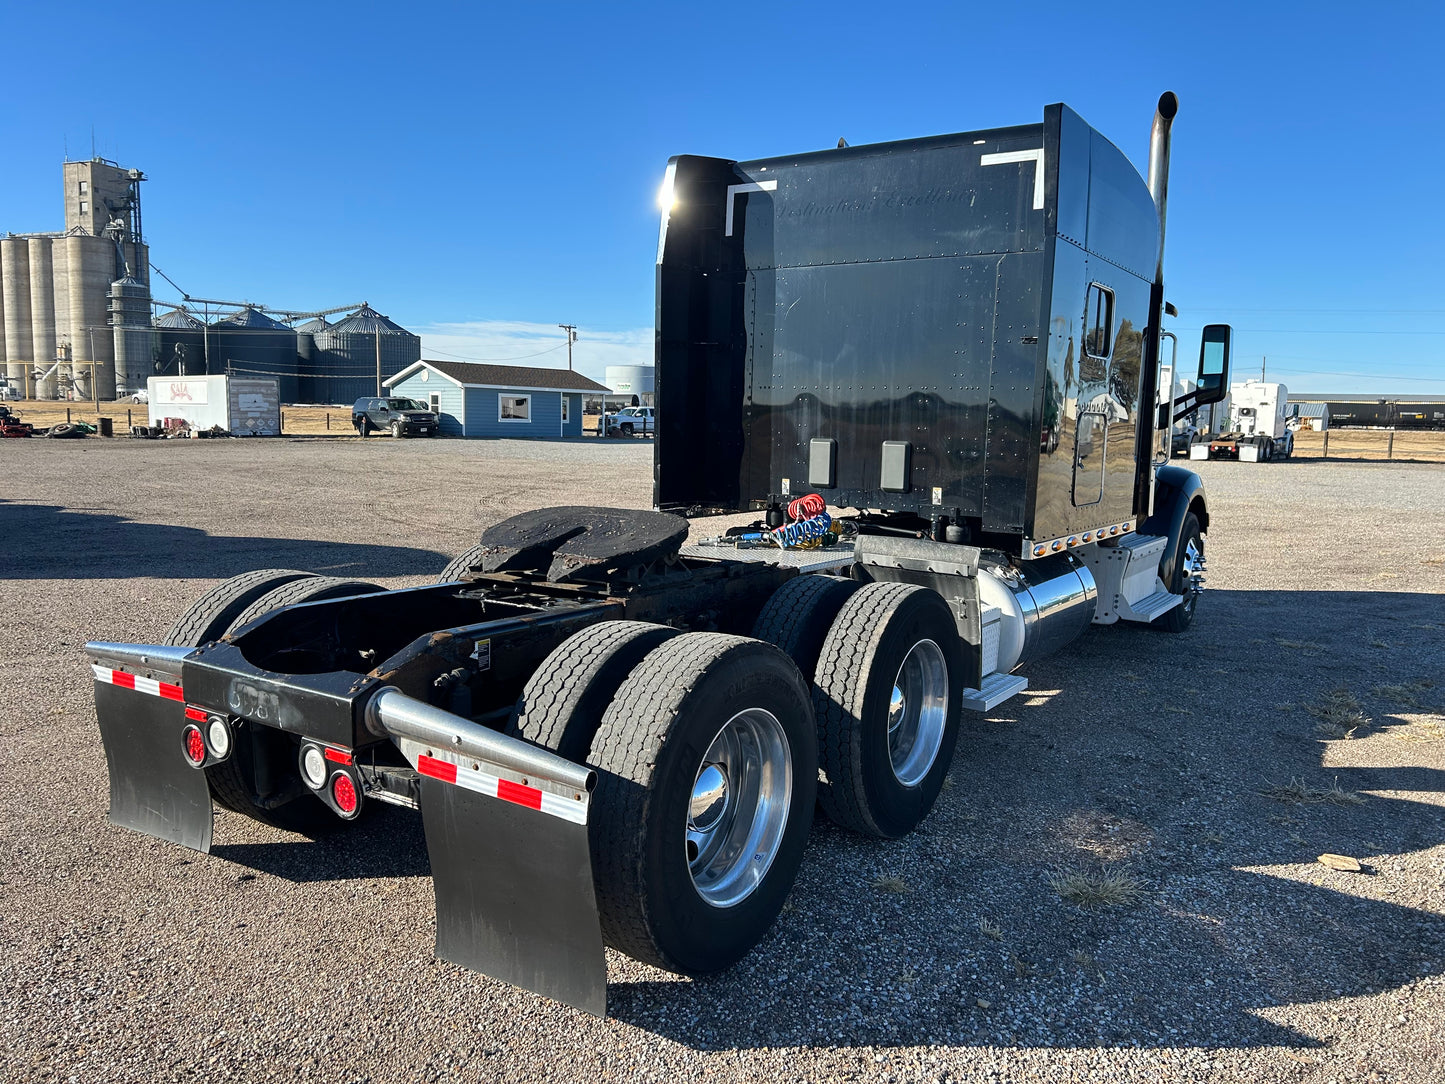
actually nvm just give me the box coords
[978,554,1098,674]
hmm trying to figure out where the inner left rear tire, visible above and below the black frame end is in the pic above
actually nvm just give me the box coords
[205,575,383,834]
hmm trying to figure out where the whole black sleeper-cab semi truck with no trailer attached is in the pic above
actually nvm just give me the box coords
[87,94,1230,1013]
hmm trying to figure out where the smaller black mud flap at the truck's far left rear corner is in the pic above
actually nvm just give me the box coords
[95,681,212,853]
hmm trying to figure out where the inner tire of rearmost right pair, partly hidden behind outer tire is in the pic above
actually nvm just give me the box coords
[512,621,679,762]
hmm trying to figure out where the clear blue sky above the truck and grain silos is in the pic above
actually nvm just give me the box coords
[0,0,1445,395]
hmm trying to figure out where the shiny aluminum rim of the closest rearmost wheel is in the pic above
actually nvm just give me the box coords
[685,708,793,908]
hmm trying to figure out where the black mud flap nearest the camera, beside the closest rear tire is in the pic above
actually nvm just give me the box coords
[420,767,607,1016]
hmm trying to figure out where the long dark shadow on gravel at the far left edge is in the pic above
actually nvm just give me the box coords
[0,499,449,580]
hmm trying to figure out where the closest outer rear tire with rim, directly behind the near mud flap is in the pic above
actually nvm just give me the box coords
[588,633,818,976]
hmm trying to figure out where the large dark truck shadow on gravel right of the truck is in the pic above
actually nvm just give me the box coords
[610,591,1445,1070]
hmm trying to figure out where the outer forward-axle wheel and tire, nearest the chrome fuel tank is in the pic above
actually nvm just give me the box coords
[814,584,964,840]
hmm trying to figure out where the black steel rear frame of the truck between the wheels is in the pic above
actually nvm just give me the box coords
[181,559,793,798]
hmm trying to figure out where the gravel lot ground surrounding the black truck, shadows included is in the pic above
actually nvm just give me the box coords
[0,439,1445,1084]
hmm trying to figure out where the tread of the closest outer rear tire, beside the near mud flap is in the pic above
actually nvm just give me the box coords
[590,633,774,970]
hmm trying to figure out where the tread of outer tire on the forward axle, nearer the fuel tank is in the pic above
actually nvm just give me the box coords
[814,584,928,835]
